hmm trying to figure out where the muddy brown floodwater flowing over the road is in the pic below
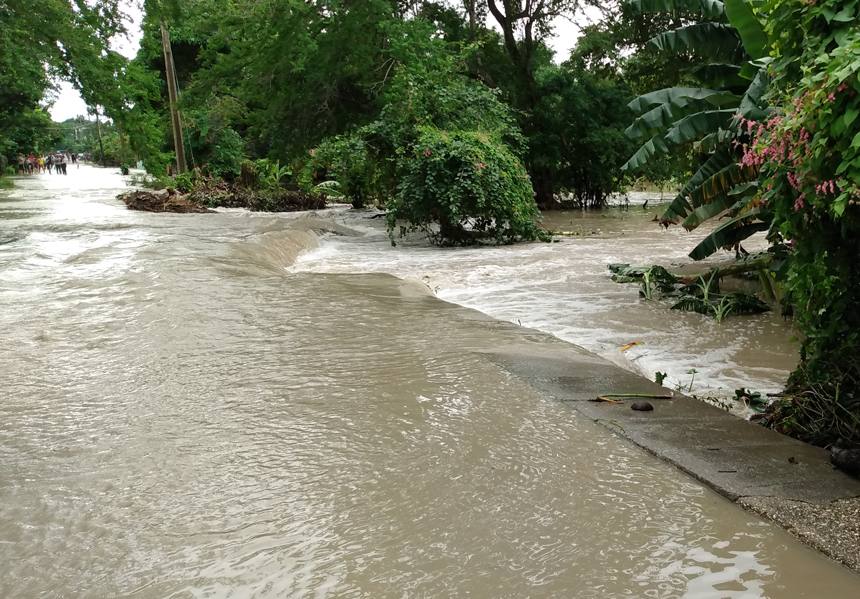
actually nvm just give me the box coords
[0,166,860,599]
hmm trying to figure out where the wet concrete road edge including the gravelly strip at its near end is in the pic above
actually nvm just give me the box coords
[444,307,860,573]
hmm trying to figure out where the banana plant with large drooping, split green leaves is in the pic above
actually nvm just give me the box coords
[622,0,772,260]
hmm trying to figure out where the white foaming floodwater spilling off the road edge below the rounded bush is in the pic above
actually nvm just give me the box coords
[290,209,797,404]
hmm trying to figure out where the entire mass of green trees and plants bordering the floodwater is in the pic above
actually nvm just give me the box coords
[5,0,860,445]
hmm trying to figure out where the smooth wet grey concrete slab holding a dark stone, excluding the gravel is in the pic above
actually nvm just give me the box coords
[485,348,860,503]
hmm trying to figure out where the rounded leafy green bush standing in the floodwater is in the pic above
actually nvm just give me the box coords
[302,54,547,244]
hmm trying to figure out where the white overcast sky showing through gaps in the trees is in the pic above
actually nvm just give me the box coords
[50,2,596,122]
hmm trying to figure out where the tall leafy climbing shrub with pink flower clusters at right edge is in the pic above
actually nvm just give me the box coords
[740,0,860,443]
